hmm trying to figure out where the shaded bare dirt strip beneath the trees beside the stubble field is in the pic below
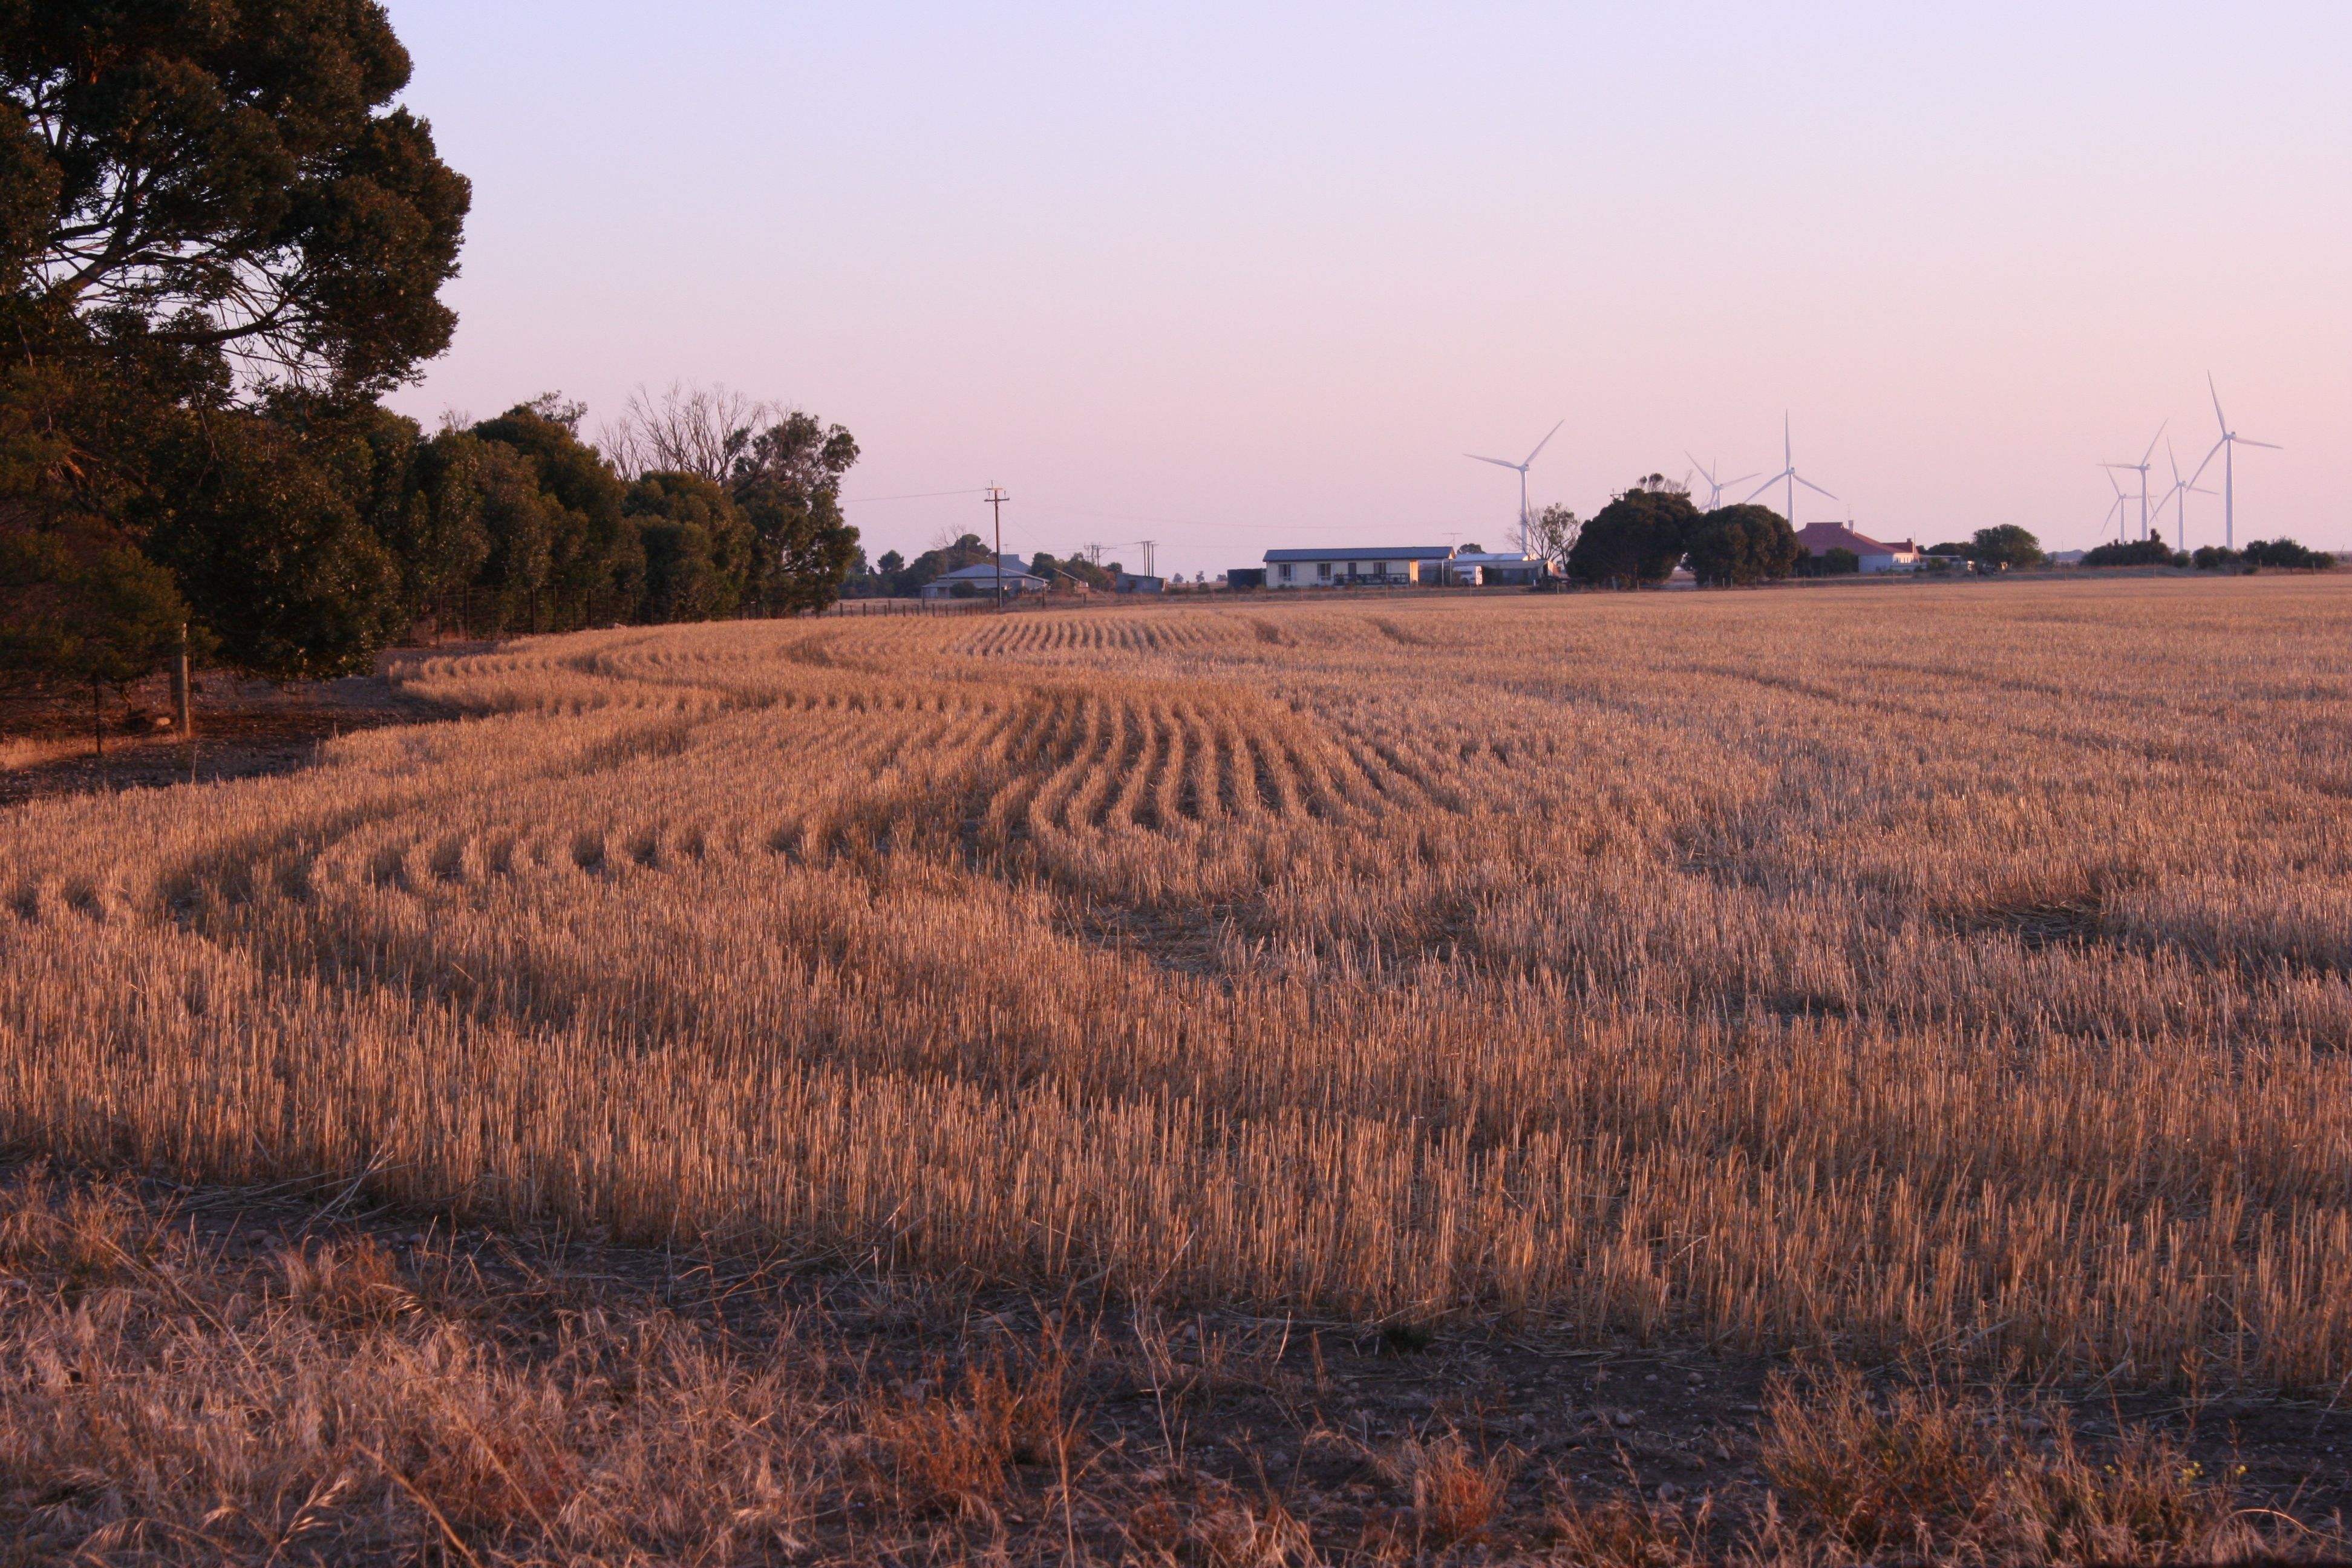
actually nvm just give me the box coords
[0,649,466,806]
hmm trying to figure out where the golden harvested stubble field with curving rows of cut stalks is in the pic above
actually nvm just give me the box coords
[0,576,2352,1561]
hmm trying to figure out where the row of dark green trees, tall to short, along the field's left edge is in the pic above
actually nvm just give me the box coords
[0,0,863,701]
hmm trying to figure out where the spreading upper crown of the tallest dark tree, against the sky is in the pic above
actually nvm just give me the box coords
[0,0,471,393]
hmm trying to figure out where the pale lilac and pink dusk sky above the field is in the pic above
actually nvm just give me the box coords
[376,0,2352,576]
